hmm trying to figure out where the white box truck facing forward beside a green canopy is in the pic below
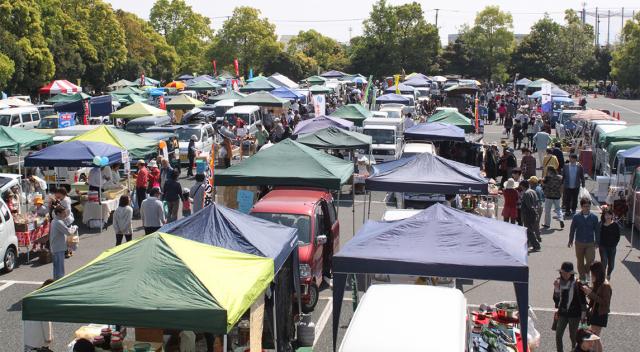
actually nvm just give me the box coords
[362,117,404,163]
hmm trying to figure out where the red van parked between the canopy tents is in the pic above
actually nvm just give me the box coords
[251,187,340,313]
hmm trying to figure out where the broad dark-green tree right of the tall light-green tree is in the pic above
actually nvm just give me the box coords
[511,10,606,83]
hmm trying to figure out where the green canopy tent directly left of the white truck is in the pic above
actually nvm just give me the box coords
[296,126,372,149]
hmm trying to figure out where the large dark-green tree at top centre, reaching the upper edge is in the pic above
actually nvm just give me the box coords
[350,0,440,76]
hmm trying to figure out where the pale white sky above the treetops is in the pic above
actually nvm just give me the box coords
[106,0,640,44]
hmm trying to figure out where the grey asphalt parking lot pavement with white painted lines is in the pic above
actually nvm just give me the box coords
[0,97,640,352]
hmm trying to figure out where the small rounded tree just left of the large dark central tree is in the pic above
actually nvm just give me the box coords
[287,29,349,75]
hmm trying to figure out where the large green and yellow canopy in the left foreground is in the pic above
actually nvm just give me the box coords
[22,232,274,334]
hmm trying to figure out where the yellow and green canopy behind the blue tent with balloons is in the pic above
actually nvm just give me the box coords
[67,126,158,160]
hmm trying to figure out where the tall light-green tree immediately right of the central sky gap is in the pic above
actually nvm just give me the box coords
[461,6,514,81]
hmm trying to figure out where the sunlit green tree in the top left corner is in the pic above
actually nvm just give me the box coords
[0,0,55,93]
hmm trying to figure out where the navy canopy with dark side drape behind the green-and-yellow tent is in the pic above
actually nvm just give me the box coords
[158,203,302,350]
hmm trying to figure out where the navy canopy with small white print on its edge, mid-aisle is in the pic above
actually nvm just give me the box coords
[365,153,489,194]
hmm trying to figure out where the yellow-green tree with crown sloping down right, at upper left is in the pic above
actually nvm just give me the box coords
[116,10,180,81]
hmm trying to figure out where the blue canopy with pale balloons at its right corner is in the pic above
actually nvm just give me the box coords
[24,141,122,167]
